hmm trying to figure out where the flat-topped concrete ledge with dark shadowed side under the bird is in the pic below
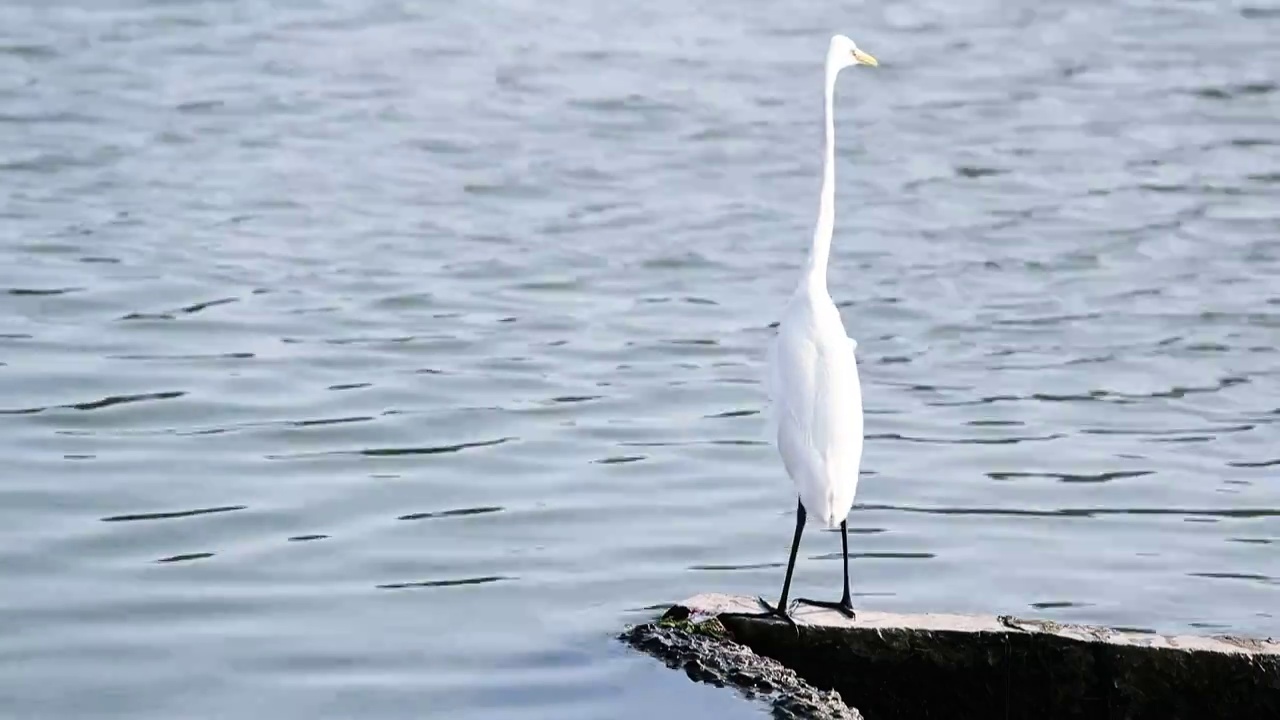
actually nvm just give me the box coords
[627,594,1280,720]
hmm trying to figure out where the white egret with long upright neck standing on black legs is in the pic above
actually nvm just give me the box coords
[760,35,879,621]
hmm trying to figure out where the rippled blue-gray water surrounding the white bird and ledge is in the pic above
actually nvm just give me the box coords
[0,0,1280,719]
